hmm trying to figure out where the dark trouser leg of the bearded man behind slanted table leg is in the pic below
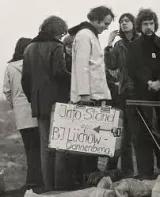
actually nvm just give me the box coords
[134,107,154,177]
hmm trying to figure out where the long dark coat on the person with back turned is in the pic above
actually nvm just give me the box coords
[22,39,70,119]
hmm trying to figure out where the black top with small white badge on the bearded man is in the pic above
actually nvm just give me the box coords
[127,35,160,100]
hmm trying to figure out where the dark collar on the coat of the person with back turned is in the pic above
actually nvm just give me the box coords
[31,31,63,44]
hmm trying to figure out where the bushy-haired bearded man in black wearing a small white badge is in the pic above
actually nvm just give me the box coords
[127,9,160,178]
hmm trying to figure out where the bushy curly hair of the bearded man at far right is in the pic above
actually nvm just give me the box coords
[136,9,158,32]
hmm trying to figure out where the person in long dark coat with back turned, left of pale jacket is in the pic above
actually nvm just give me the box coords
[22,16,70,191]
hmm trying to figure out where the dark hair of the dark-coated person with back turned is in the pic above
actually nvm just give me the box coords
[40,15,68,37]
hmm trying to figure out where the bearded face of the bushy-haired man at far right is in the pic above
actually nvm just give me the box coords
[142,19,155,36]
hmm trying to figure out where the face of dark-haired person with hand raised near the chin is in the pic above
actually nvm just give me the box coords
[120,16,133,33]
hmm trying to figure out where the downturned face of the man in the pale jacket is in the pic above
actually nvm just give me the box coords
[94,15,113,34]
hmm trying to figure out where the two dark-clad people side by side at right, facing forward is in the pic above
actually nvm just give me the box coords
[105,9,160,182]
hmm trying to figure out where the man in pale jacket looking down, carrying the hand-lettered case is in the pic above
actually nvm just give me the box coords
[69,6,114,184]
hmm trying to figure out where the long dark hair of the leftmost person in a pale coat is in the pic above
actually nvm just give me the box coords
[9,38,31,62]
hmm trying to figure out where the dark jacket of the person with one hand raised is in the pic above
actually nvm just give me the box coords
[104,37,136,95]
